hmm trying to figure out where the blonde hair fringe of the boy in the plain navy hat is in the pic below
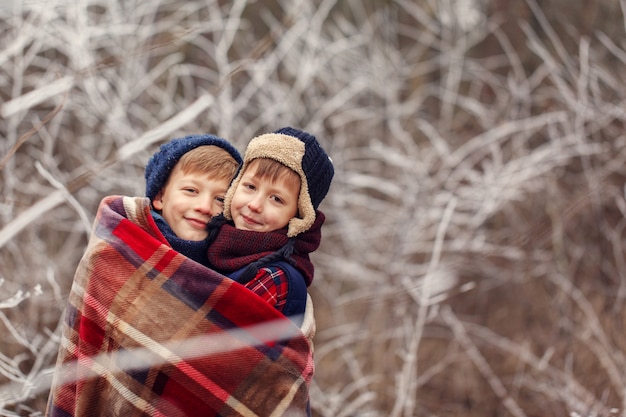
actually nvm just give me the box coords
[176,145,239,181]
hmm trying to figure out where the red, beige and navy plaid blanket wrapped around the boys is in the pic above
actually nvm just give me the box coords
[47,196,315,417]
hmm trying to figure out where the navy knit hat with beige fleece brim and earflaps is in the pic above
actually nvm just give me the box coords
[224,127,335,237]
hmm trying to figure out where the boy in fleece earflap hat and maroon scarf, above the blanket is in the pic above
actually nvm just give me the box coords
[208,127,334,324]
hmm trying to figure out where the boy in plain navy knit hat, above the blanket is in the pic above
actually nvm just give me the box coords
[145,135,242,265]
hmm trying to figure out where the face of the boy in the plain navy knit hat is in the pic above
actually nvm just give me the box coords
[152,166,229,241]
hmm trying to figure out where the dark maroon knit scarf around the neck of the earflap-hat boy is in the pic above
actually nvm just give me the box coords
[208,211,325,287]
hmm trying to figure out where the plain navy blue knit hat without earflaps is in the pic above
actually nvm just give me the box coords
[145,134,242,200]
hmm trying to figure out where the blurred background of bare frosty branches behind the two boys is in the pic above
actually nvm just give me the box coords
[0,0,626,417]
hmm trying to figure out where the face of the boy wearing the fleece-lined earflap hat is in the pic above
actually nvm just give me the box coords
[230,166,300,232]
